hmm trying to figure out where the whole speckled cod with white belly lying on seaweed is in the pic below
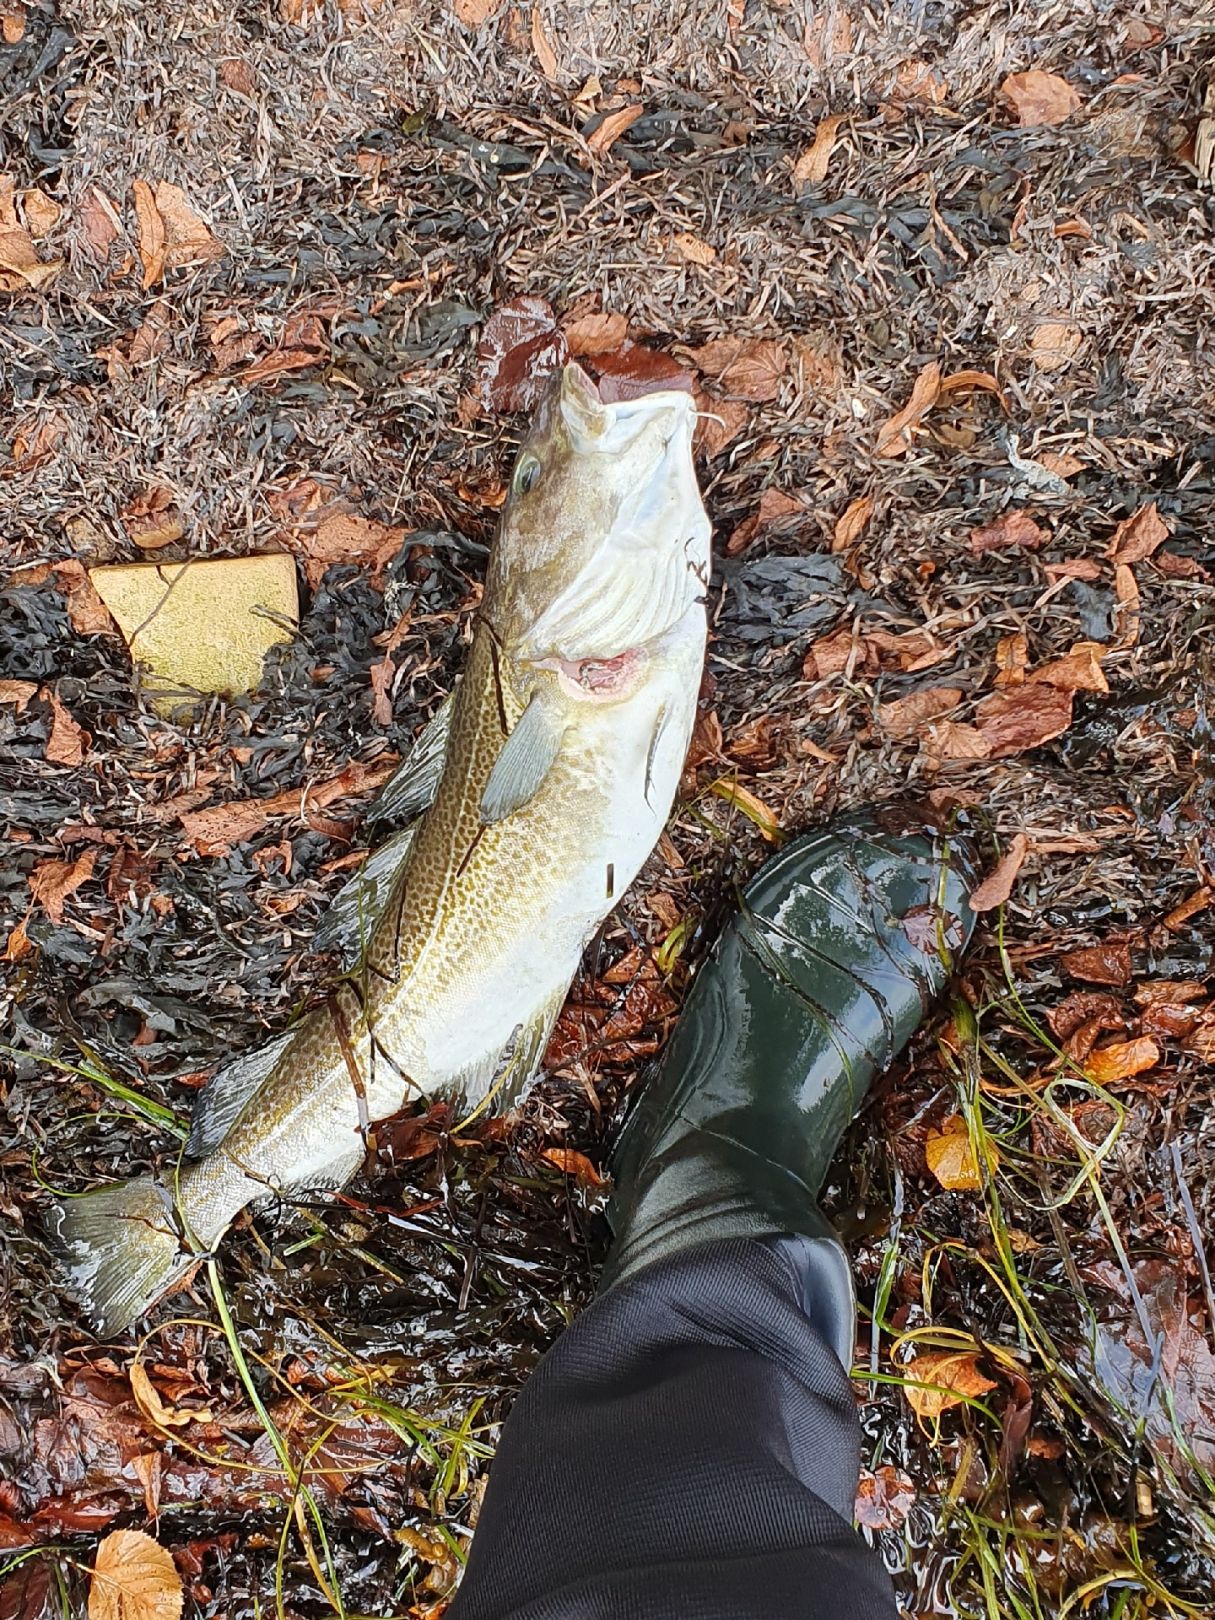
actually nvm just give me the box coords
[53,365,710,1335]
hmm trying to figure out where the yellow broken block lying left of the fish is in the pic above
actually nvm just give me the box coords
[89,552,300,714]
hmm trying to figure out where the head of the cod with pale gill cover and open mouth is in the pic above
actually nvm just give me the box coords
[483,363,710,685]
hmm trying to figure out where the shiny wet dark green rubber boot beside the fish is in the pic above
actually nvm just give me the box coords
[604,816,974,1359]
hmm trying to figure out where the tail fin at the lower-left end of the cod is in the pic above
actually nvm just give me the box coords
[50,1176,196,1338]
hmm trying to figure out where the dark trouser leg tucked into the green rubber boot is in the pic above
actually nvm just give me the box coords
[449,1238,896,1620]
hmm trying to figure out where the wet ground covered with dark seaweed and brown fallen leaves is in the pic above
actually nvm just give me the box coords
[0,0,1215,1620]
